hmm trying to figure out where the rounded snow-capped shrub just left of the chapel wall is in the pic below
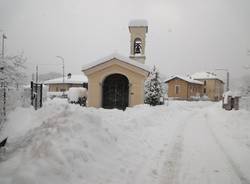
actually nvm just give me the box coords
[68,87,87,106]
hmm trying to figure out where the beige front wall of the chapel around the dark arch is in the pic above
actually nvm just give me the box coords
[83,58,148,108]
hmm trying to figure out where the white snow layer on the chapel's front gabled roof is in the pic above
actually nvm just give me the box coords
[82,53,151,72]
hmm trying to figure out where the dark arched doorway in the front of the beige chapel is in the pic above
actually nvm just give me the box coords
[102,74,129,110]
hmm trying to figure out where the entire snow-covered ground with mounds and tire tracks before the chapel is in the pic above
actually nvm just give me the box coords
[0,99,250,184]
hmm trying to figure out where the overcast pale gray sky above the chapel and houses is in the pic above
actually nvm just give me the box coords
[0,0,250,80]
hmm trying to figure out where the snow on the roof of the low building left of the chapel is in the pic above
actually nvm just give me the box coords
[44,74,88,84]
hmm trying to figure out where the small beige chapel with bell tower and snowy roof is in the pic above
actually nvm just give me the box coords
[82,20,150,109]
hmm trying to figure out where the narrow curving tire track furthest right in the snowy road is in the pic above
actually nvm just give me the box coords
[205,114,250,184]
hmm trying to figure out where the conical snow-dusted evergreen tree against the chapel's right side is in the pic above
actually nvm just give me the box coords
[144,67,164,106]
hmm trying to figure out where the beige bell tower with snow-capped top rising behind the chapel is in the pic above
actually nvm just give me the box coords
[129,20,148,64]
